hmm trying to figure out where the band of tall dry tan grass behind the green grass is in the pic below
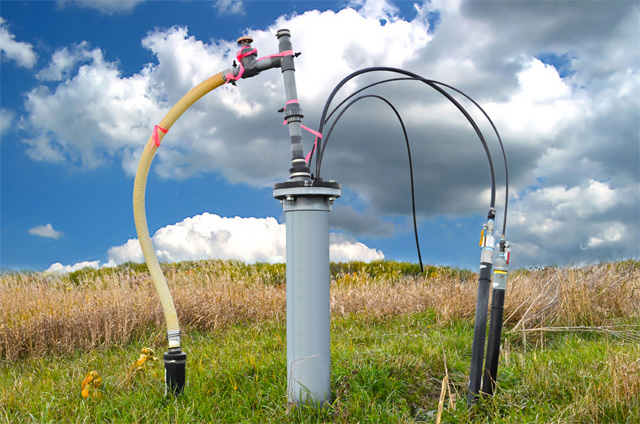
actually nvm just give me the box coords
[0,261,640,360]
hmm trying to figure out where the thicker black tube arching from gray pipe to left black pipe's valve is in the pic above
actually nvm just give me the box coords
[316,67,496,209]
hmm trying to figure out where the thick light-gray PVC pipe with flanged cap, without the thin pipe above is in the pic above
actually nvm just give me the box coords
[274,187,340,407]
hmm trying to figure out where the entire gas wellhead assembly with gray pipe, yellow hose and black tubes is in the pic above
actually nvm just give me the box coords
[133,29,509,407]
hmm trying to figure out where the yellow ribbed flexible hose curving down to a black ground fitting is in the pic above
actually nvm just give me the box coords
[133,72,225,348]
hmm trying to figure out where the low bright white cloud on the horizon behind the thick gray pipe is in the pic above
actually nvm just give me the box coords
[108,213,384,264]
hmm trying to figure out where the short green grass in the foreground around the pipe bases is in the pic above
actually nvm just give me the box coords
[0,312,640,423]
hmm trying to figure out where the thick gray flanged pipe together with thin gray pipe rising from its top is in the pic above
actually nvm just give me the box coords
[273,29,340,407]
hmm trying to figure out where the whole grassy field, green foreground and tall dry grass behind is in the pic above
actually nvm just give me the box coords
[0,261,640,423]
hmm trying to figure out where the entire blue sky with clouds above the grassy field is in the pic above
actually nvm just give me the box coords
[0,0,640,272]
